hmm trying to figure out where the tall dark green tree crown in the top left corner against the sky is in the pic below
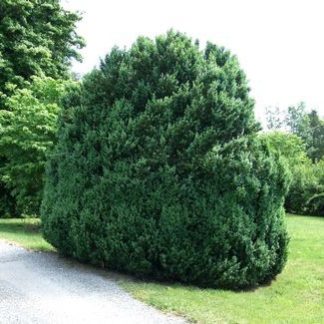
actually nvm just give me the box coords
[0,0,84,100]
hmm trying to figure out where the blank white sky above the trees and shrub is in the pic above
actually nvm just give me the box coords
[62,0,324,120]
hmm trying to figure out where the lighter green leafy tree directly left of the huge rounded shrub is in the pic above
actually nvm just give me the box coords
[0,77,74,214]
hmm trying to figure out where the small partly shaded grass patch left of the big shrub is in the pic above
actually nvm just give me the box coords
[0,218,55,252]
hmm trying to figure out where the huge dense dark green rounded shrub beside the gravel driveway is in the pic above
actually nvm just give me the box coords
[42,31,287,289]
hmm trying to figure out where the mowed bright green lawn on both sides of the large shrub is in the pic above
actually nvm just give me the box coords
[0,216,324,323]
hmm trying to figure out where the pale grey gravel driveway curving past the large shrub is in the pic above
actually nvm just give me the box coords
[0,241,185,324]
